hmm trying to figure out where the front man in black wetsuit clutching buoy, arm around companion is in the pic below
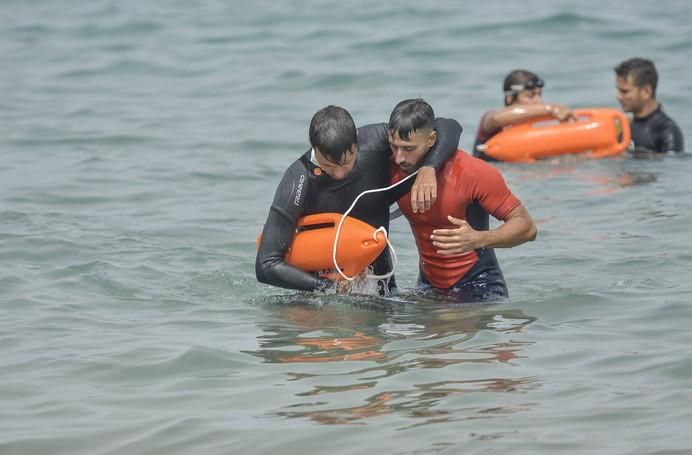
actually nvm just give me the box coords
[255,106,462,294]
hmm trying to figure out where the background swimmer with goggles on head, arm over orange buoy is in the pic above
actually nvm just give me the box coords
[473,69,574,161]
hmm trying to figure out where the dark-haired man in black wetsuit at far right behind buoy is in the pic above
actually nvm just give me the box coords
[615,58,684,153]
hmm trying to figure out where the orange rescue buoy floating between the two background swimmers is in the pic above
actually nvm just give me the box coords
[482,108,630,161]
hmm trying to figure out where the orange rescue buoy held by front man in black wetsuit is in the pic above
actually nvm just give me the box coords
[257,213,387,279]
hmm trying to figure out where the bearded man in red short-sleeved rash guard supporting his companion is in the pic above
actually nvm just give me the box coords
[389,98,537,302]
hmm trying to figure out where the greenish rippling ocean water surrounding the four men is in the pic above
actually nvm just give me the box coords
[0,0,692,455]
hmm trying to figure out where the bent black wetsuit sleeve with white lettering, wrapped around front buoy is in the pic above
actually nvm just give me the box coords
[255,162,332,291]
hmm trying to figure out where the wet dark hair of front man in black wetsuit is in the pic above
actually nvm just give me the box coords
[309,105,356,164]
